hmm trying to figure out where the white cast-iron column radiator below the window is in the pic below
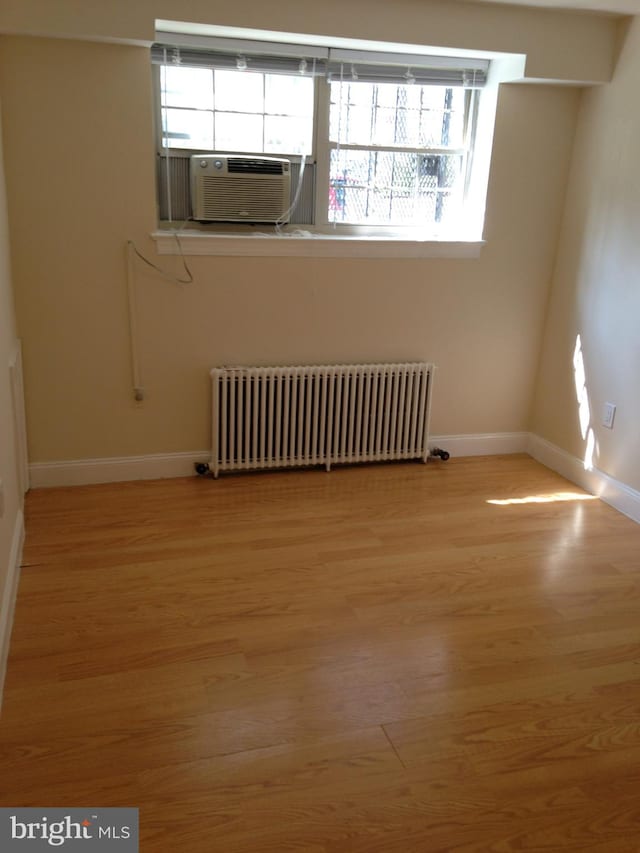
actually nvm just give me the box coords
[210,363,434,477]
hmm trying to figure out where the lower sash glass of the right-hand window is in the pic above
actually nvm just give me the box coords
[329,150,463,226]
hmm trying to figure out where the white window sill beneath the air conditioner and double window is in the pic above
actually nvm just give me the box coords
[151,229,484,258]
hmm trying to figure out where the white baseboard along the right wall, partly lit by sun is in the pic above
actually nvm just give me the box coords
[528,434,640,523]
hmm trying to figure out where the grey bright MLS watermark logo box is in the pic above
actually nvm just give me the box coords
[0,808,139,853]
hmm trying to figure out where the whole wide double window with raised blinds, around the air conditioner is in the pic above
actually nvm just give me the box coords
[152,39,489,236]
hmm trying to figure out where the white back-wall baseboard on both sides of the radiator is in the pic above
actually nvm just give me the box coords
[29,432,529,488]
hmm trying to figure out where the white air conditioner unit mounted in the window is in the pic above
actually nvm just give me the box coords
[191,154,291,222]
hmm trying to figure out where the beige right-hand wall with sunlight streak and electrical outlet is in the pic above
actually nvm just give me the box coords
[532,13,640,489]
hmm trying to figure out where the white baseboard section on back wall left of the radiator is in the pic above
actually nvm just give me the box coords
[29,450,211,488]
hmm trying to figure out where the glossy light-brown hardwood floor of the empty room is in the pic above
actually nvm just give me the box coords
[0,456,640,853]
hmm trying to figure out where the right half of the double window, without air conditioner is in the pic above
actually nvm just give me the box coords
[328,82,470,226]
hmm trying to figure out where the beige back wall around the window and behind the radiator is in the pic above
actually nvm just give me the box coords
[0,37,579,462]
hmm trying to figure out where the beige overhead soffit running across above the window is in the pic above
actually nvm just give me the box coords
[0,0,616,81]
